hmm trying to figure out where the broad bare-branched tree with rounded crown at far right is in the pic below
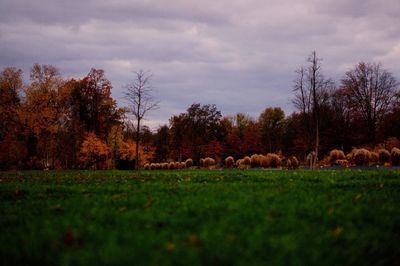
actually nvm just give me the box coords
[342,62,398,144]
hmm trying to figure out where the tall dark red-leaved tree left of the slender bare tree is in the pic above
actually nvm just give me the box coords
[59,68,124,167]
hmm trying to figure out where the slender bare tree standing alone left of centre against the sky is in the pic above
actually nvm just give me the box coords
[124,70,159,170]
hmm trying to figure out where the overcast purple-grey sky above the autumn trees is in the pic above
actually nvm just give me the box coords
[0,0,400,128]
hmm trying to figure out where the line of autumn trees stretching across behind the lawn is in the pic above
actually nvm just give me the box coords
[0,52,400,170]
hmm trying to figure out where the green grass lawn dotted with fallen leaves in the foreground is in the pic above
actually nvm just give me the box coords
[0,170,400,265]
